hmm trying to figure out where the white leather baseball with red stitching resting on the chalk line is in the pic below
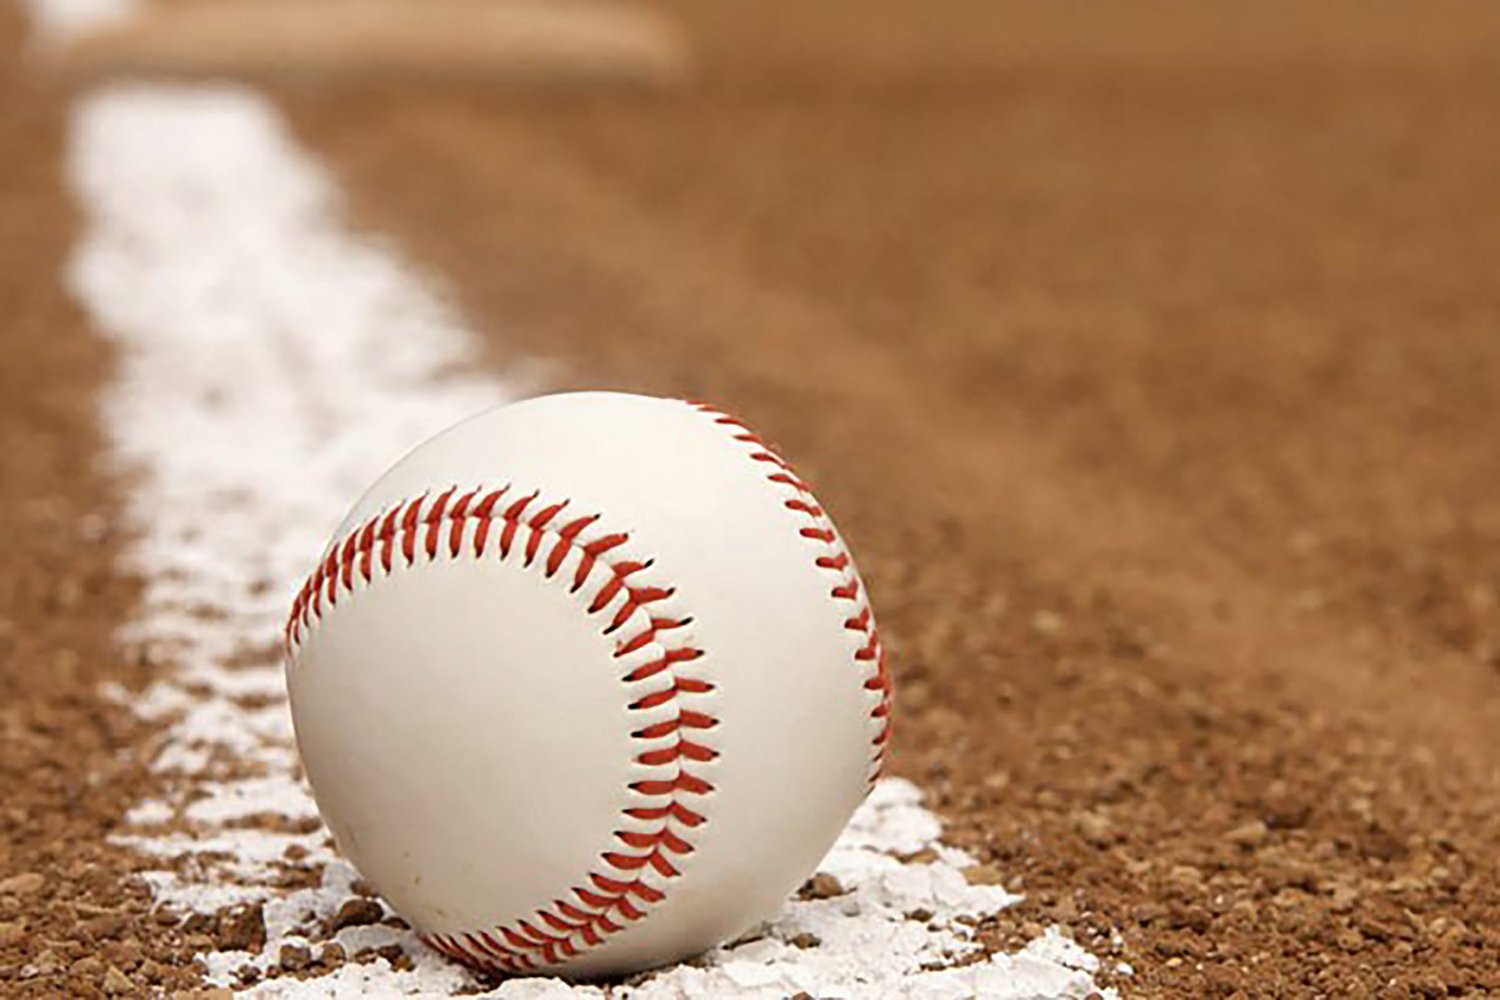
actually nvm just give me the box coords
[287,393,890,976]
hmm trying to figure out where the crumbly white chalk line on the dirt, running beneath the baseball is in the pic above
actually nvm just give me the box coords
[69,87,1116,999]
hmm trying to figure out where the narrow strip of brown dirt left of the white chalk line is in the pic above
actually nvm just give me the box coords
[0,4,234,997]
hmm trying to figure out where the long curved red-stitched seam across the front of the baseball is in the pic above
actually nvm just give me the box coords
[285,487,719,975]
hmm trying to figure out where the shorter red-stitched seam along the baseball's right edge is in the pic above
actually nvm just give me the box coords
[689,402,891,784]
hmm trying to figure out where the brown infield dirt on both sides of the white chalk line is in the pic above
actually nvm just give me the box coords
[0,0,1500,996]
